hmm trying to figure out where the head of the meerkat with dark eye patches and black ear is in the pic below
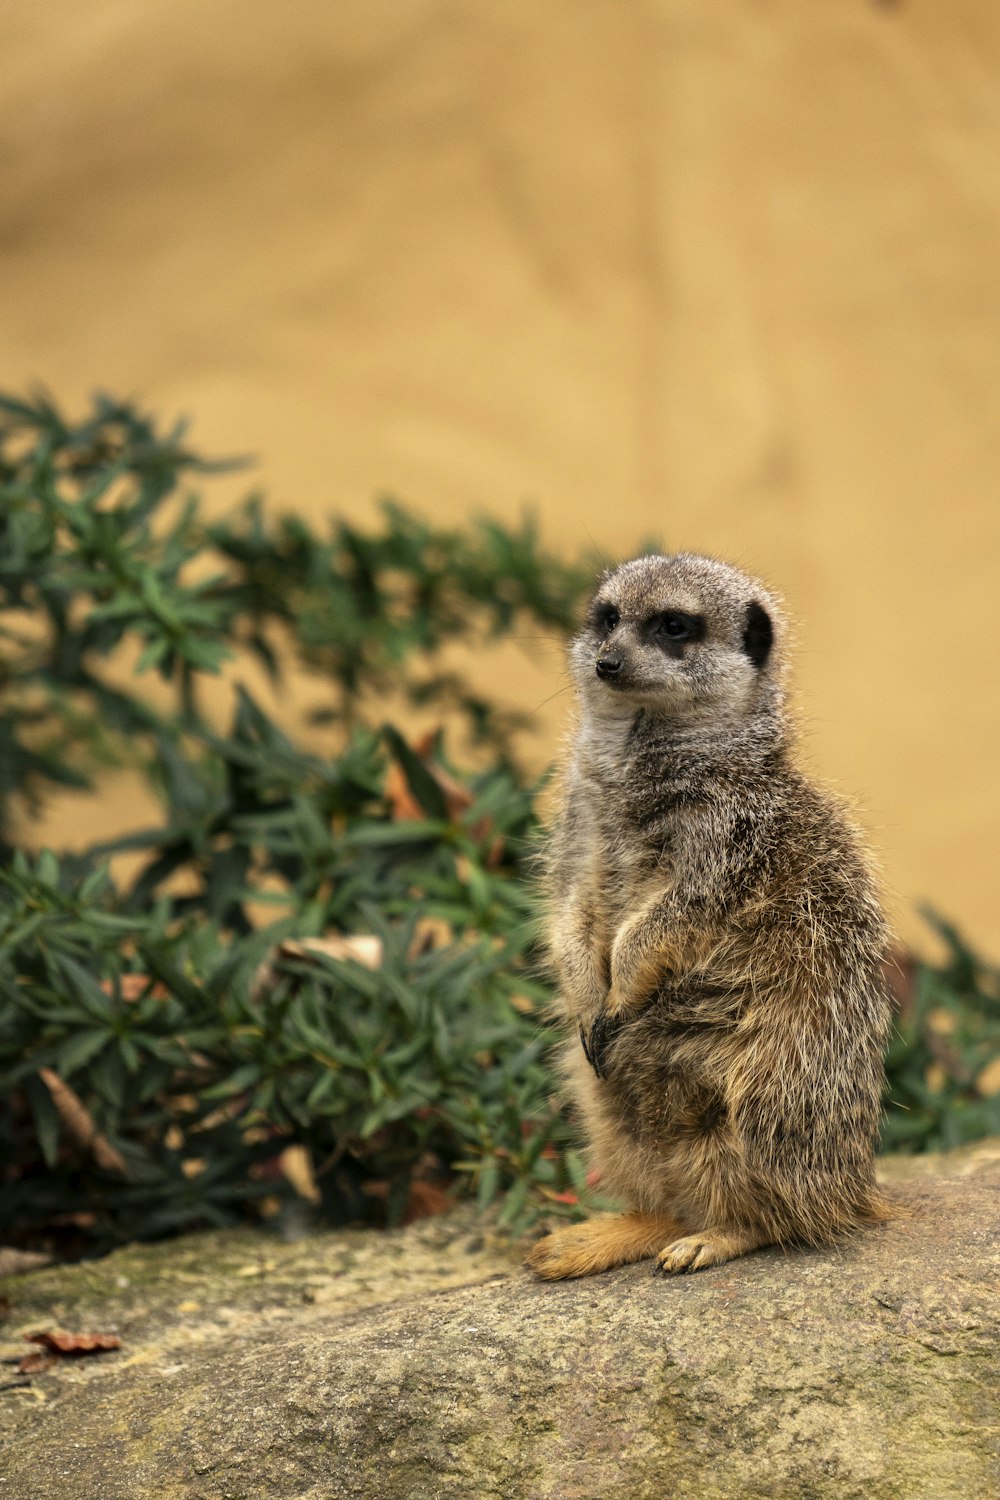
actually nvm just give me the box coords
[570,554,784,722]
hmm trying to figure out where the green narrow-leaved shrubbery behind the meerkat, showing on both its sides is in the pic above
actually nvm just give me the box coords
[0,399,1000,1245]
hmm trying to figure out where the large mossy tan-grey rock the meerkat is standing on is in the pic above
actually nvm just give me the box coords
[0,1143,1000,1500]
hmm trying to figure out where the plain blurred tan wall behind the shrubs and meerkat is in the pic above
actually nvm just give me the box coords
[0,0,1000,953]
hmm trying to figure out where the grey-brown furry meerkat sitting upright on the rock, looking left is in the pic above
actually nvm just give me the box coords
[529,554,891,1278]
